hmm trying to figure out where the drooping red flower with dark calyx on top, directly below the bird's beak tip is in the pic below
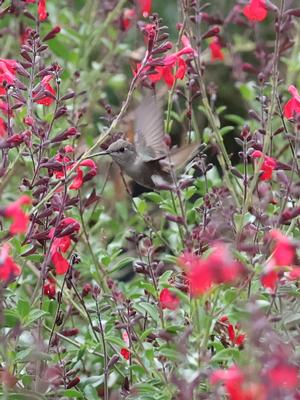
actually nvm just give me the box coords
[49,218,80,275]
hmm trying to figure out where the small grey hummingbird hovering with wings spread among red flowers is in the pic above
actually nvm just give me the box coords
[94,97,201,190]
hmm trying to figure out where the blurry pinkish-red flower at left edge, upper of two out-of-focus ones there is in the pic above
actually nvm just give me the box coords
[4,196,31,235]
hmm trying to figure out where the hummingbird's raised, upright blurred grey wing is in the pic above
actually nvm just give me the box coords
[134,96,168,162]
